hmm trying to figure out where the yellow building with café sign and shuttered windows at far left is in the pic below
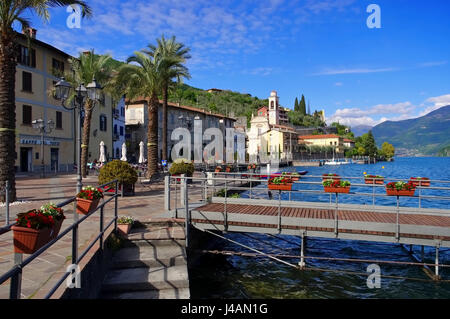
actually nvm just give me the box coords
[15,33,75,172]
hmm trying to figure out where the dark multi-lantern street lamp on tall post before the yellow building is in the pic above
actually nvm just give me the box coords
[55,78,102,193]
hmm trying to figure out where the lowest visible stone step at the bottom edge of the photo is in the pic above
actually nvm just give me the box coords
[102,288,191,299]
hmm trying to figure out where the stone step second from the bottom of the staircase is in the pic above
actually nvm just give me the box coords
[102,265,189,292]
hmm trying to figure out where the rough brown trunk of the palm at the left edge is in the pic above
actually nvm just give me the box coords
[0,34,17,202]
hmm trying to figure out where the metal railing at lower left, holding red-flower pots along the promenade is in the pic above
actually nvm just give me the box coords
[0,180,123,299]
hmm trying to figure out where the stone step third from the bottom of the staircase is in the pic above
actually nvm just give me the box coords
[113,244,187,269]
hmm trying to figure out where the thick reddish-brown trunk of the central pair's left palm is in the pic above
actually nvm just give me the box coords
[147,94,159,178]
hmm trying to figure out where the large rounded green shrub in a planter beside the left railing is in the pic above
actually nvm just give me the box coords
[98,160,138,185]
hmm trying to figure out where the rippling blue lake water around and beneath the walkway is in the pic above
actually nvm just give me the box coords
[189,158,450,299]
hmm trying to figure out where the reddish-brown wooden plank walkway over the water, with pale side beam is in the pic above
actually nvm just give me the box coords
[174,198,450,247]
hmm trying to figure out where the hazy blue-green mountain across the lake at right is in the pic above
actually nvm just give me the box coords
[372,105,450,156]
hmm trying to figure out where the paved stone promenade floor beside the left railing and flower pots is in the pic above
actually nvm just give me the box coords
[0,175,201,299]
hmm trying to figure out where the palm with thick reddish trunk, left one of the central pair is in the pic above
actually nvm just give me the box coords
[115,51,166,178]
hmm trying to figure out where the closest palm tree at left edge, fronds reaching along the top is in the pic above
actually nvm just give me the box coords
[0,0,91,202]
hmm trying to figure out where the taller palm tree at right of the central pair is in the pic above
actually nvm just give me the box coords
[143,35,191,160]
